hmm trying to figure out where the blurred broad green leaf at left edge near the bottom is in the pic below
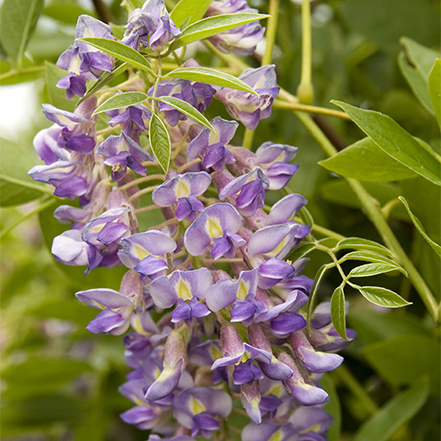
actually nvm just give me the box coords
[2,358,92,398]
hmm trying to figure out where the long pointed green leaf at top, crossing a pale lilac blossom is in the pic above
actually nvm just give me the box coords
[171,12,269,49]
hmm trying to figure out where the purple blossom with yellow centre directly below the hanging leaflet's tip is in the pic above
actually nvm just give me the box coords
[152,172,211,222]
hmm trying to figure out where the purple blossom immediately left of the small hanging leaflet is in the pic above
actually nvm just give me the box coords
[96,132,153,181]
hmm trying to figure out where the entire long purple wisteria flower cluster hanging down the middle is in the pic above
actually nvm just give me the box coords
[29,0,353,441]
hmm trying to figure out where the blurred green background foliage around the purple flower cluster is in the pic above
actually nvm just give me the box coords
[0,0,441,441]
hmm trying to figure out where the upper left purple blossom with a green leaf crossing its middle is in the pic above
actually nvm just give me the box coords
[57,15,113,99]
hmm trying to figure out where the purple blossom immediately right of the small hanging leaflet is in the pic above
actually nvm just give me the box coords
[187,116,238,171]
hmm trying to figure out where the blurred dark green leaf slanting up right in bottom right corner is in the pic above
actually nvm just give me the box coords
[353,377,429,441]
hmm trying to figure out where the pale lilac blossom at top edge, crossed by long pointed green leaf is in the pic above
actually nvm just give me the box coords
[205,0,265,56]
